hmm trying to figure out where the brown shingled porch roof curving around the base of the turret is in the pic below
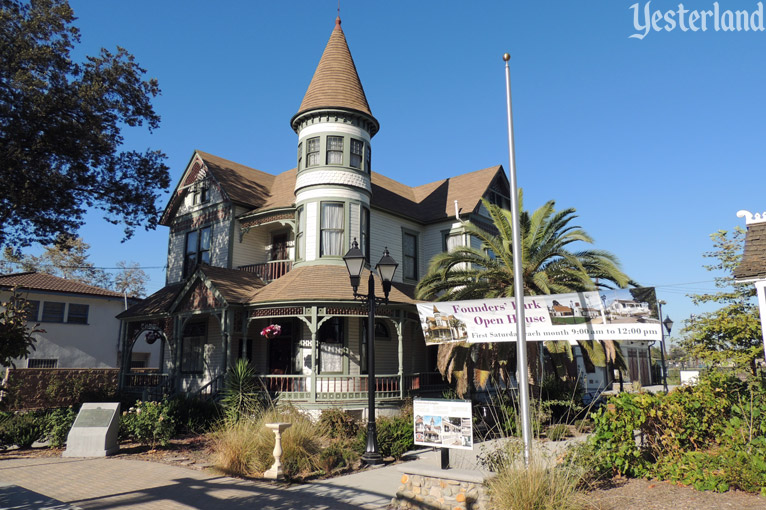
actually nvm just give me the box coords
[250,265,417,304]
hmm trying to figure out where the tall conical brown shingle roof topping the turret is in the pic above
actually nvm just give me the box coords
[296,17,372,116]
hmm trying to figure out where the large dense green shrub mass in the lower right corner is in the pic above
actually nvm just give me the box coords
[589,373,766,492]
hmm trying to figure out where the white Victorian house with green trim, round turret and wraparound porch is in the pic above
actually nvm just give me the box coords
[119,18,509,409]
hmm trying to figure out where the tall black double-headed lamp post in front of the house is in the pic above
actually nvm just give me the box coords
[343,238,399,465]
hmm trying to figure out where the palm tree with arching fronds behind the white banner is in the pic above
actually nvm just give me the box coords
[416,190,633,394]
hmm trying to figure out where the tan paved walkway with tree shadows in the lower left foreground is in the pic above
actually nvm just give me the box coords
[0,458,414,510]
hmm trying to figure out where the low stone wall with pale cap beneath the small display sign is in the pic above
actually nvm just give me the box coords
[391,463,490,510]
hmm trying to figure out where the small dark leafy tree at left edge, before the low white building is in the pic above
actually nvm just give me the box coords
[0,289,44,367]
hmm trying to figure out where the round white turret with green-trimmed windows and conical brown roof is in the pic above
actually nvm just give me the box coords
[291,17,380,265]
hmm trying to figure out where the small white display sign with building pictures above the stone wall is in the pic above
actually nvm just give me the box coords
[412,399,473,450]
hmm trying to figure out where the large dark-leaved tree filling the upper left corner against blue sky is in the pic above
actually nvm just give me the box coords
[0,0,170,247]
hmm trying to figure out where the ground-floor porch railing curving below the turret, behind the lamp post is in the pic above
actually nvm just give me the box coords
[259,372,446,402]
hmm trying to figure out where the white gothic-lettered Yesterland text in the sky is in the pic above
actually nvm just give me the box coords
[629,1,764,39]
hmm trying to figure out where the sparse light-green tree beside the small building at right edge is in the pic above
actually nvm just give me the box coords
[681,227,763,374]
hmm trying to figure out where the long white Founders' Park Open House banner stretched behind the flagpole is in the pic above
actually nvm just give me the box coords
[418,287,662,344]
